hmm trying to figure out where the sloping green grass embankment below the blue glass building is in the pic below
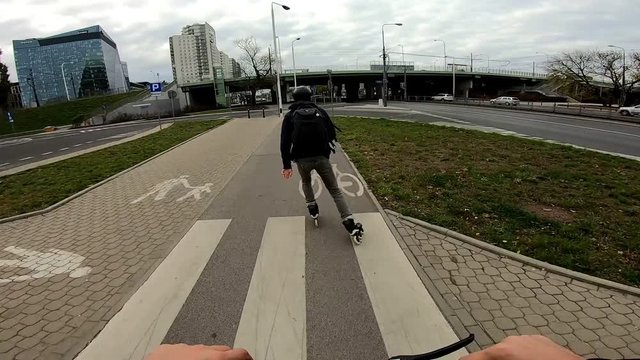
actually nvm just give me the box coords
[0,91,146,135]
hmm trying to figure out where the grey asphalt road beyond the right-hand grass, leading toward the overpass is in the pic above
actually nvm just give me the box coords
[329,102,640,156]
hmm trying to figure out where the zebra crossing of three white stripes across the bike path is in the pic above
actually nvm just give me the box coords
[77,212,463,360]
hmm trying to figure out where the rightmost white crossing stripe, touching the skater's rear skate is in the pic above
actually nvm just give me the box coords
[354,213,466,360]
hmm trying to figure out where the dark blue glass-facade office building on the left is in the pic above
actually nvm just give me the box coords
[13,25,129,107]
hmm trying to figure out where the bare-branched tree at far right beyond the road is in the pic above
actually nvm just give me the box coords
[548,50,640,105]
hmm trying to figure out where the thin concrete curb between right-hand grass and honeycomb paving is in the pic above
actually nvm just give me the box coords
[386,210,640,296]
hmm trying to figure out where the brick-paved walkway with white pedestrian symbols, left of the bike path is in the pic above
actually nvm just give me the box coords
[0,117,279,360]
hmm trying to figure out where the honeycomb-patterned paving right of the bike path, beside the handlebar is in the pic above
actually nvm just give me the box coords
[389,213,640,359]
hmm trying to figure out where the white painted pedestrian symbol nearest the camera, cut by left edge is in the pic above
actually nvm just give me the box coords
[0,246,91,284]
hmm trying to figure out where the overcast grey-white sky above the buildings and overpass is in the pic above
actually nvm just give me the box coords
[0,0,640,81]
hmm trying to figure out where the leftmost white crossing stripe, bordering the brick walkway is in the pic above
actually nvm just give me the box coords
[76,220,231,360]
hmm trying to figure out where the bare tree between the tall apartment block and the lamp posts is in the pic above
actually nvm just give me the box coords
[234,36,275,106]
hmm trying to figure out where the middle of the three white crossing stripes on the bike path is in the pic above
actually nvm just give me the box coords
[234,216,307,360]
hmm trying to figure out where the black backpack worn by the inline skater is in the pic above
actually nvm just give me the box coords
[291,105,336,153]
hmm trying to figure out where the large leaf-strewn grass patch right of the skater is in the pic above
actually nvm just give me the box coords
[336,118,640,286]
